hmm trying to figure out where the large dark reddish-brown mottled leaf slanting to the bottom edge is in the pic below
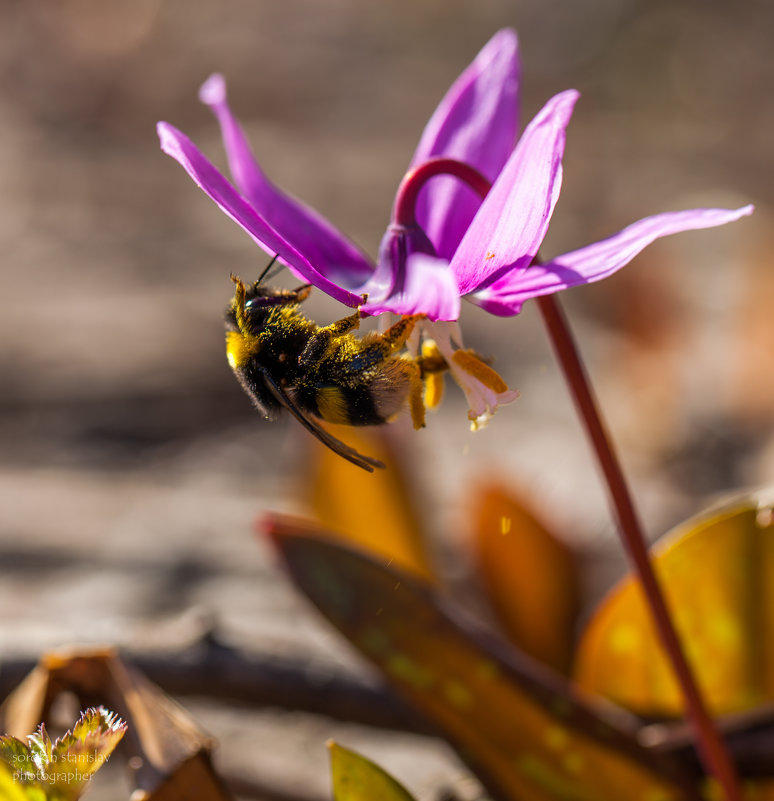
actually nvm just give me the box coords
[266,518,696,801]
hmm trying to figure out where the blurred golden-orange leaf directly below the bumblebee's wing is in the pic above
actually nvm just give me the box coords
[302,424,432,578]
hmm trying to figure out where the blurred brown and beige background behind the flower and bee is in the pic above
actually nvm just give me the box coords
[0,0,774,796]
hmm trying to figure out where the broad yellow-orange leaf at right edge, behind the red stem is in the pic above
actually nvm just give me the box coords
[575,493,774,716]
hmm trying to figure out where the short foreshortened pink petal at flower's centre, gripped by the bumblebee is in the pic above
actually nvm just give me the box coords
[361,253,460,321]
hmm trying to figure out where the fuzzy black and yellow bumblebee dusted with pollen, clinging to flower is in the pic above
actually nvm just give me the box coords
[226,276,446,472]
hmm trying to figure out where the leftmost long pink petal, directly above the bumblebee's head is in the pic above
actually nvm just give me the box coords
[157,122,361,306]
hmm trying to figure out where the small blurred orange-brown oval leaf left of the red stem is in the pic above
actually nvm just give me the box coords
[473,485,578,673]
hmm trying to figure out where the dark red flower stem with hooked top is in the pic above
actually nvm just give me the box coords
[393,159,742,801]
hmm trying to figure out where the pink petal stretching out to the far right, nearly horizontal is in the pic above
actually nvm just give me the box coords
[470,206,753,317]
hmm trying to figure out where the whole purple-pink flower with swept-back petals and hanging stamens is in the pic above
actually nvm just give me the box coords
[158,30,752,424]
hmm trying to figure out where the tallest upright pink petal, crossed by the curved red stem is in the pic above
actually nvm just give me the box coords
[411,29,520,260]
